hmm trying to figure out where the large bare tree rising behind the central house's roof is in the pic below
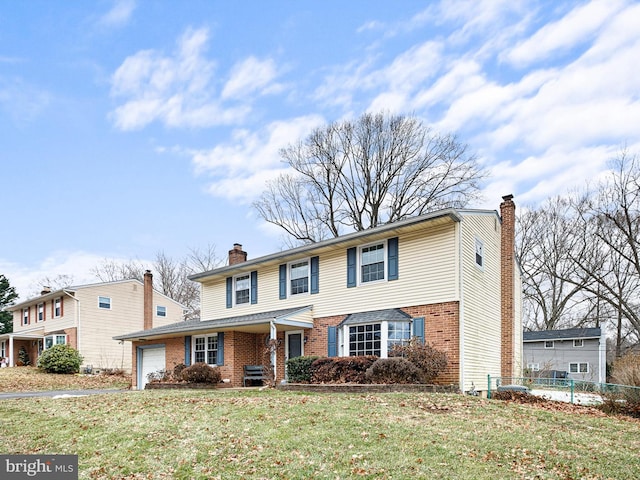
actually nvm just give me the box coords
[254,113,487,243]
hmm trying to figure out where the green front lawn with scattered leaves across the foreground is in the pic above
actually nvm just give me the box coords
[0,390,640,480]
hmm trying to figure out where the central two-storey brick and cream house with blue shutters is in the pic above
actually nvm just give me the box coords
[115,195,522,390]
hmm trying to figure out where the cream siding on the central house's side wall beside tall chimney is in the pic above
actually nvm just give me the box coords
[460,212,501,390]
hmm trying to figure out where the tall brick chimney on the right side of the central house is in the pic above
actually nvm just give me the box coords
[500,195,516,377]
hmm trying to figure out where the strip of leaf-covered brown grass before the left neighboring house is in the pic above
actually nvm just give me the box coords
[0,367,131,392]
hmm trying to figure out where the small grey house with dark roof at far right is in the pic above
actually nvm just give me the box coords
[523,328,607,383]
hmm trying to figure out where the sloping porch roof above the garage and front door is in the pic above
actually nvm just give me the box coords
[113,306,313,342]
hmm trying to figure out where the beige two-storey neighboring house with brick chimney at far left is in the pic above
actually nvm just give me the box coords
[0,271,184,372]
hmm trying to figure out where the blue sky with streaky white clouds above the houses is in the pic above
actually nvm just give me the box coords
[0,0,640,299]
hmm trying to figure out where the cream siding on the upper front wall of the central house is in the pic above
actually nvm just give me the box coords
[201,222,459,320]
